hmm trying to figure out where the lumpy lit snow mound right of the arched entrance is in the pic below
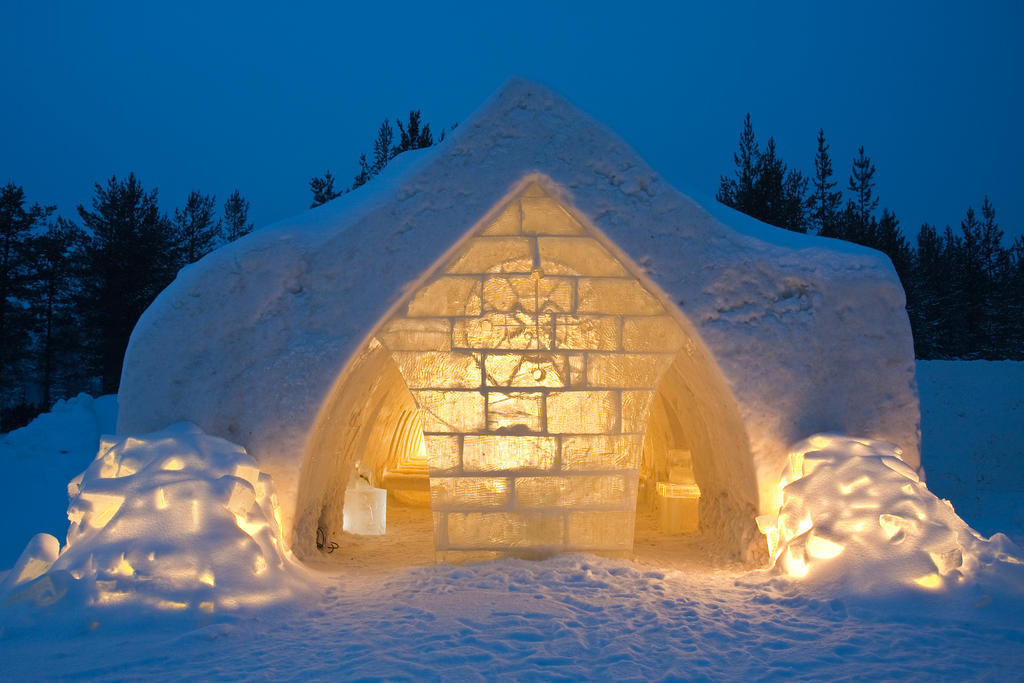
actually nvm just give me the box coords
[758,434,1024,594]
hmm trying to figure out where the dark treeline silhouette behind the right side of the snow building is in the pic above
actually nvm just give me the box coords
[716,114,1024,360]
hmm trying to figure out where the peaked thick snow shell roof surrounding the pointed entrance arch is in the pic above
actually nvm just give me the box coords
[118,79,920,548]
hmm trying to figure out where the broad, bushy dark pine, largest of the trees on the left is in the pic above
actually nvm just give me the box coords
[78,173,176,393]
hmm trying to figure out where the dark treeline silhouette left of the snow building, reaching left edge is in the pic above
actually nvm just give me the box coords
[0,179,253,431]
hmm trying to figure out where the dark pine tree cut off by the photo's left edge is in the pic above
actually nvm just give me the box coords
[0,183,54,408]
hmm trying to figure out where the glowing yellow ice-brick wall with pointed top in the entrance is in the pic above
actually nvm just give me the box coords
[378,184,684,558]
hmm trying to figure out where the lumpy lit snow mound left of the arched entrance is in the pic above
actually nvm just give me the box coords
[5,423,293,612]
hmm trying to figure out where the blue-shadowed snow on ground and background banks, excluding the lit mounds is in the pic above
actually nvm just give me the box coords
[0,362,1024,680]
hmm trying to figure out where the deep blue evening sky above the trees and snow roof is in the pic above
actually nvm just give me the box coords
[0,0,1024,242]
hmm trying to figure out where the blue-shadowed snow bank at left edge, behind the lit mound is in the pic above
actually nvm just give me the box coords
[0,393,118,569]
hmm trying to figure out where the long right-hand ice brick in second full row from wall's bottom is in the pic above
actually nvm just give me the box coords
[515,473,633,508]
